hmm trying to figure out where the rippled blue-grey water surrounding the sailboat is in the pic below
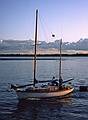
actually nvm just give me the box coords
[0,57,88,120]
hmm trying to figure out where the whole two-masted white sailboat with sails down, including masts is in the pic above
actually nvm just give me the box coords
[11,10,74,99]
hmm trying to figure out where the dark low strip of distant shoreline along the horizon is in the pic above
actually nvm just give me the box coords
[0,54,88,60]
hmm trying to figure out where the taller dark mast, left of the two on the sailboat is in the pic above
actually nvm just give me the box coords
[33,9,38,86]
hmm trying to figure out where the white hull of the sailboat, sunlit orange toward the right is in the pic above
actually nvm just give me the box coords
[16,88,74,99]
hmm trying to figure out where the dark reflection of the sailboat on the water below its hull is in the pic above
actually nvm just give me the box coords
[11,96,72,120]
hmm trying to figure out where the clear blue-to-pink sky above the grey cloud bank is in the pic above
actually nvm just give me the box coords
[0,0,88,42]
